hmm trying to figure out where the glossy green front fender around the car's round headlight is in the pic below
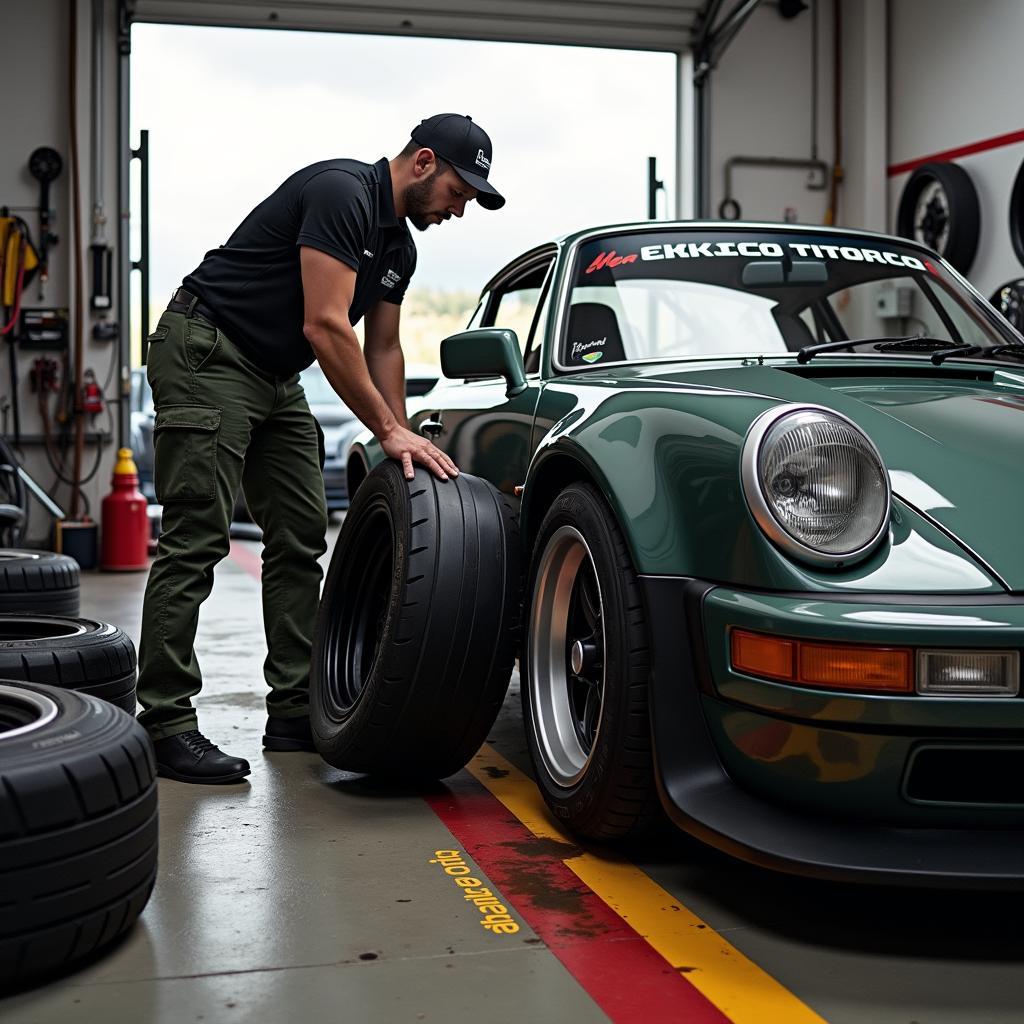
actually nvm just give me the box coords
[523,389,999,592]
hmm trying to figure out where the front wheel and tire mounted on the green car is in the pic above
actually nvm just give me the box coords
[519,482,663,840]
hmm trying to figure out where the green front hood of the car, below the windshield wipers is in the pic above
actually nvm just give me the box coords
[607,360,1024,591]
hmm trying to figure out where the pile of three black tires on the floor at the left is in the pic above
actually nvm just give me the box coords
[0,549,158,991]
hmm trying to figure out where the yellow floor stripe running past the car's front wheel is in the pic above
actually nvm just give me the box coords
[468,745,824,1024]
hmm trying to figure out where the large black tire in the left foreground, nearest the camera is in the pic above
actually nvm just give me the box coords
[0,681,158,991]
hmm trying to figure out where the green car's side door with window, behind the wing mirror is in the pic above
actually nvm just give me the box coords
[412,247,556,495]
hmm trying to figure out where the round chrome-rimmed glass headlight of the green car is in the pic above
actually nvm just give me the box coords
[742,406,890,566]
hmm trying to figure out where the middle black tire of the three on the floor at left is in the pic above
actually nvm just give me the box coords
[0,615,136,715]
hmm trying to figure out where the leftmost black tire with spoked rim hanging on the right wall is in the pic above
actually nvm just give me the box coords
[896,163,981,273]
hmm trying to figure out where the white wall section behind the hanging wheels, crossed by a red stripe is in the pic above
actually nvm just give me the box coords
[889,0,1024,295]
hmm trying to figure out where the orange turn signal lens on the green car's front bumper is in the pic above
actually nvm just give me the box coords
[730,630,913,693]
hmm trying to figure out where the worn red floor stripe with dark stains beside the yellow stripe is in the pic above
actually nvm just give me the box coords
[425,778,729,1024]
